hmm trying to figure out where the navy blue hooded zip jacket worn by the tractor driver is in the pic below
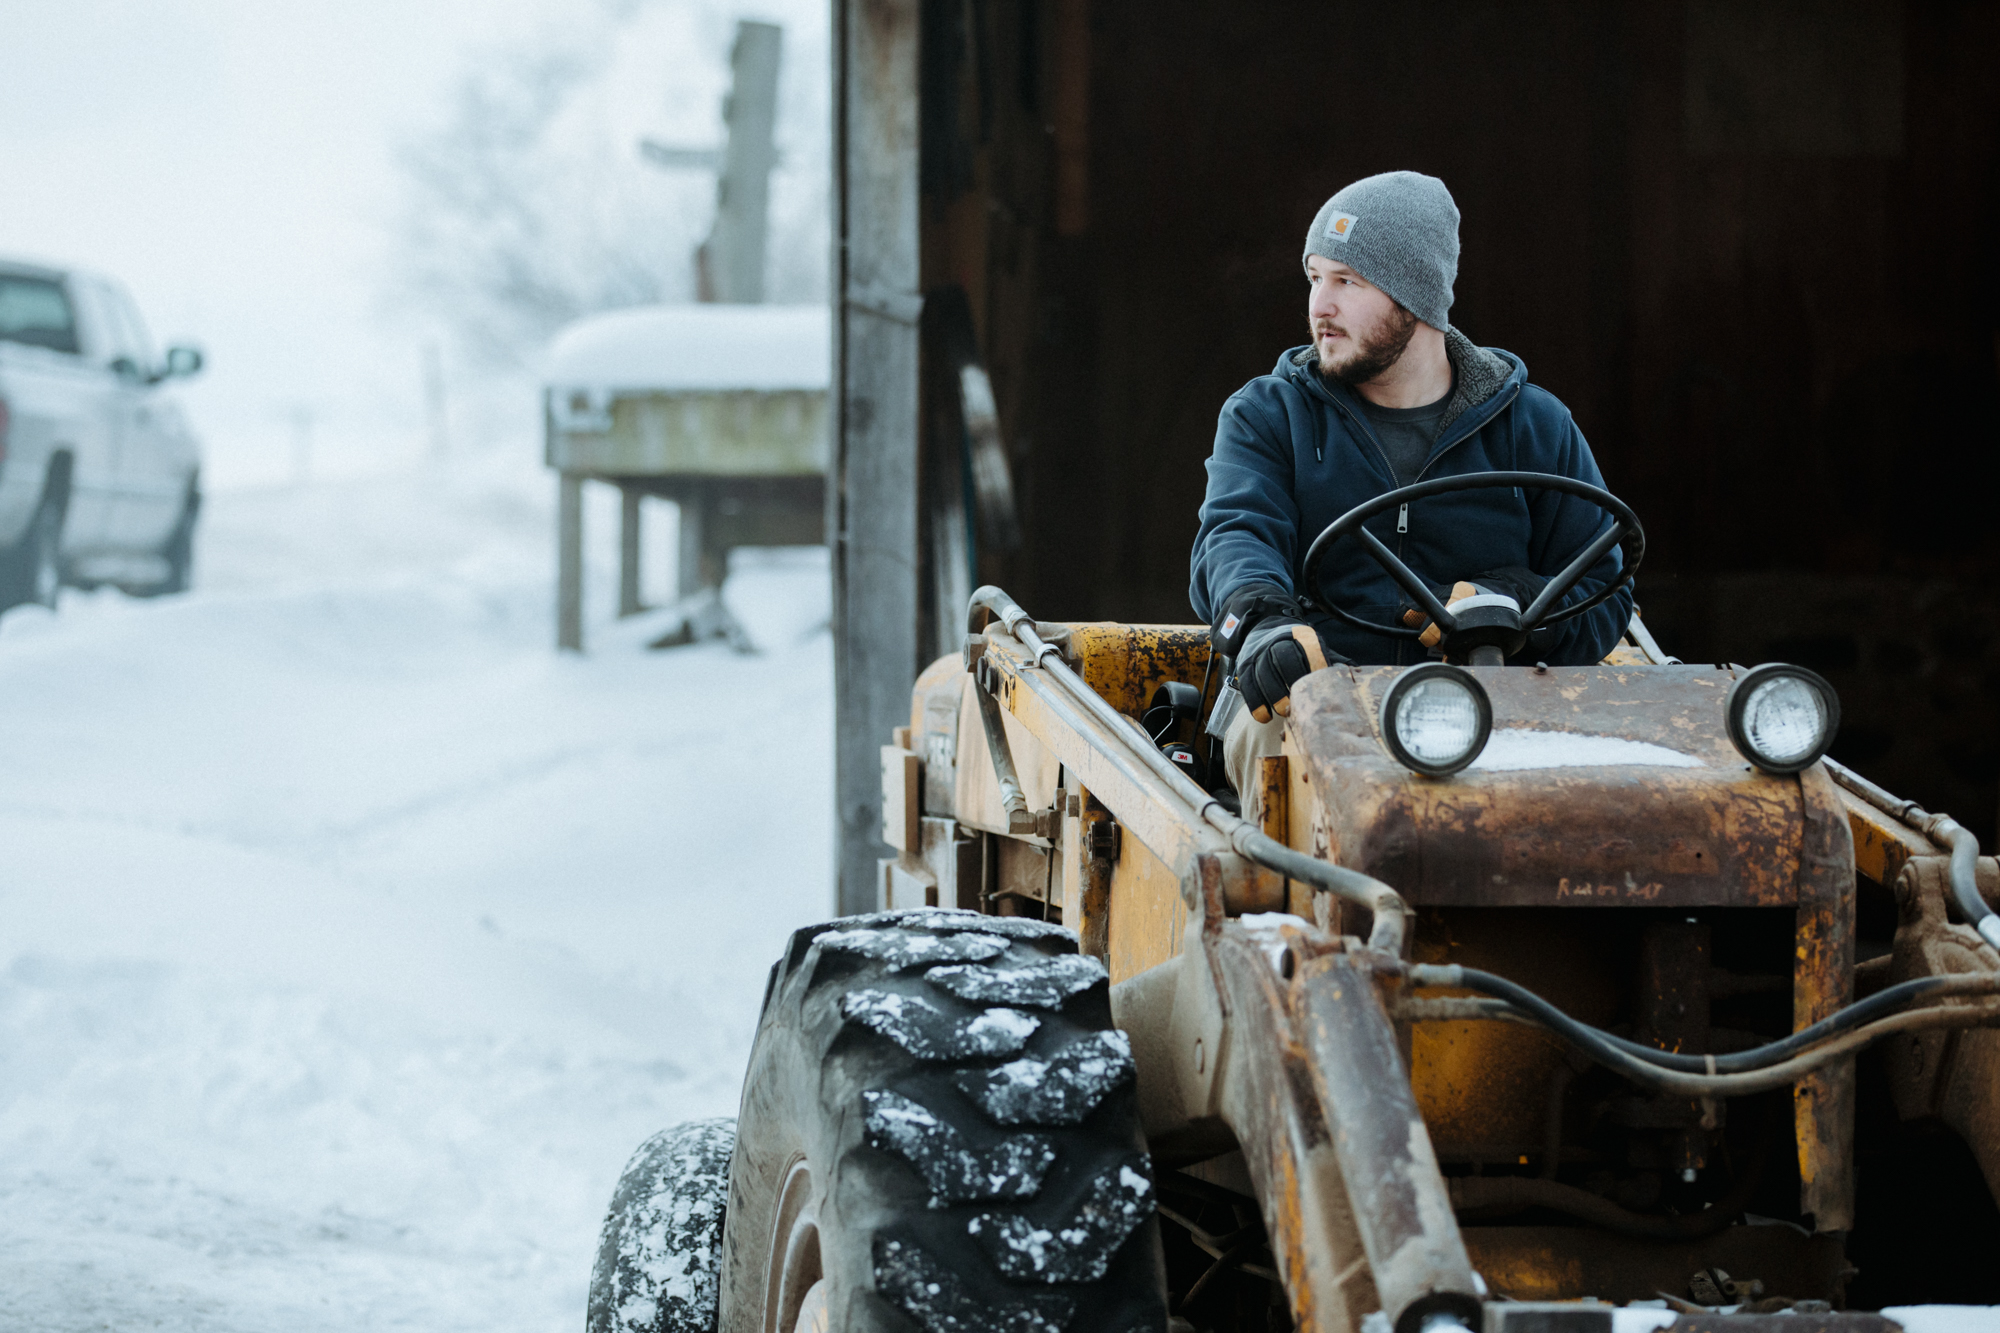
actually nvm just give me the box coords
[1188,328,1632,664]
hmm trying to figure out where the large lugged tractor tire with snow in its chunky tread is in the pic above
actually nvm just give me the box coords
[722,909,1166,1333]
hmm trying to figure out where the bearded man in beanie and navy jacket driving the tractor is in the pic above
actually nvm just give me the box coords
[1188,172,1632,791]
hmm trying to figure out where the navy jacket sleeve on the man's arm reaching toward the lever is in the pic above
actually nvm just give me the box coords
[1188,392,1298,622]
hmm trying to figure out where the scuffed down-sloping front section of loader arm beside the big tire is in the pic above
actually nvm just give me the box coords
[1112,917,1480,1333]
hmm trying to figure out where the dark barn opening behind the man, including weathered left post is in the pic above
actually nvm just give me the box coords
[834,0,2000,907]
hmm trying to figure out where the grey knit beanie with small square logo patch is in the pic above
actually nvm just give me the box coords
[1306,172,1458,332]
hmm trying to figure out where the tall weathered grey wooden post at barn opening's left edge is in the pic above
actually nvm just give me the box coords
[826,0,922,913]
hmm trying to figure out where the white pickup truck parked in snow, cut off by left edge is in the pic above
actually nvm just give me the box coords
[0,260,202,610]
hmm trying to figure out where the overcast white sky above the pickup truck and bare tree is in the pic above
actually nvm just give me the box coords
[0,0,826,486]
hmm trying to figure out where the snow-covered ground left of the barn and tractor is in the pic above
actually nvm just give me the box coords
[0,460,832,1333]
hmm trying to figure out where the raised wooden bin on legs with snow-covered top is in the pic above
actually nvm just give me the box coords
[542,304,832,648]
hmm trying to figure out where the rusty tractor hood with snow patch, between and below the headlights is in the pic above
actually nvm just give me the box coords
[1286,667,1812,907]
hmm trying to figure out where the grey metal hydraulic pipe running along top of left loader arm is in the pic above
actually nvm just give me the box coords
[968,584,1410,957]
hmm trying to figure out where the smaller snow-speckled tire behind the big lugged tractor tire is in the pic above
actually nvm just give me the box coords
[584,1119,736,1333]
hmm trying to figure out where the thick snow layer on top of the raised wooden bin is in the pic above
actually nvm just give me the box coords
[542,304,834,392]
